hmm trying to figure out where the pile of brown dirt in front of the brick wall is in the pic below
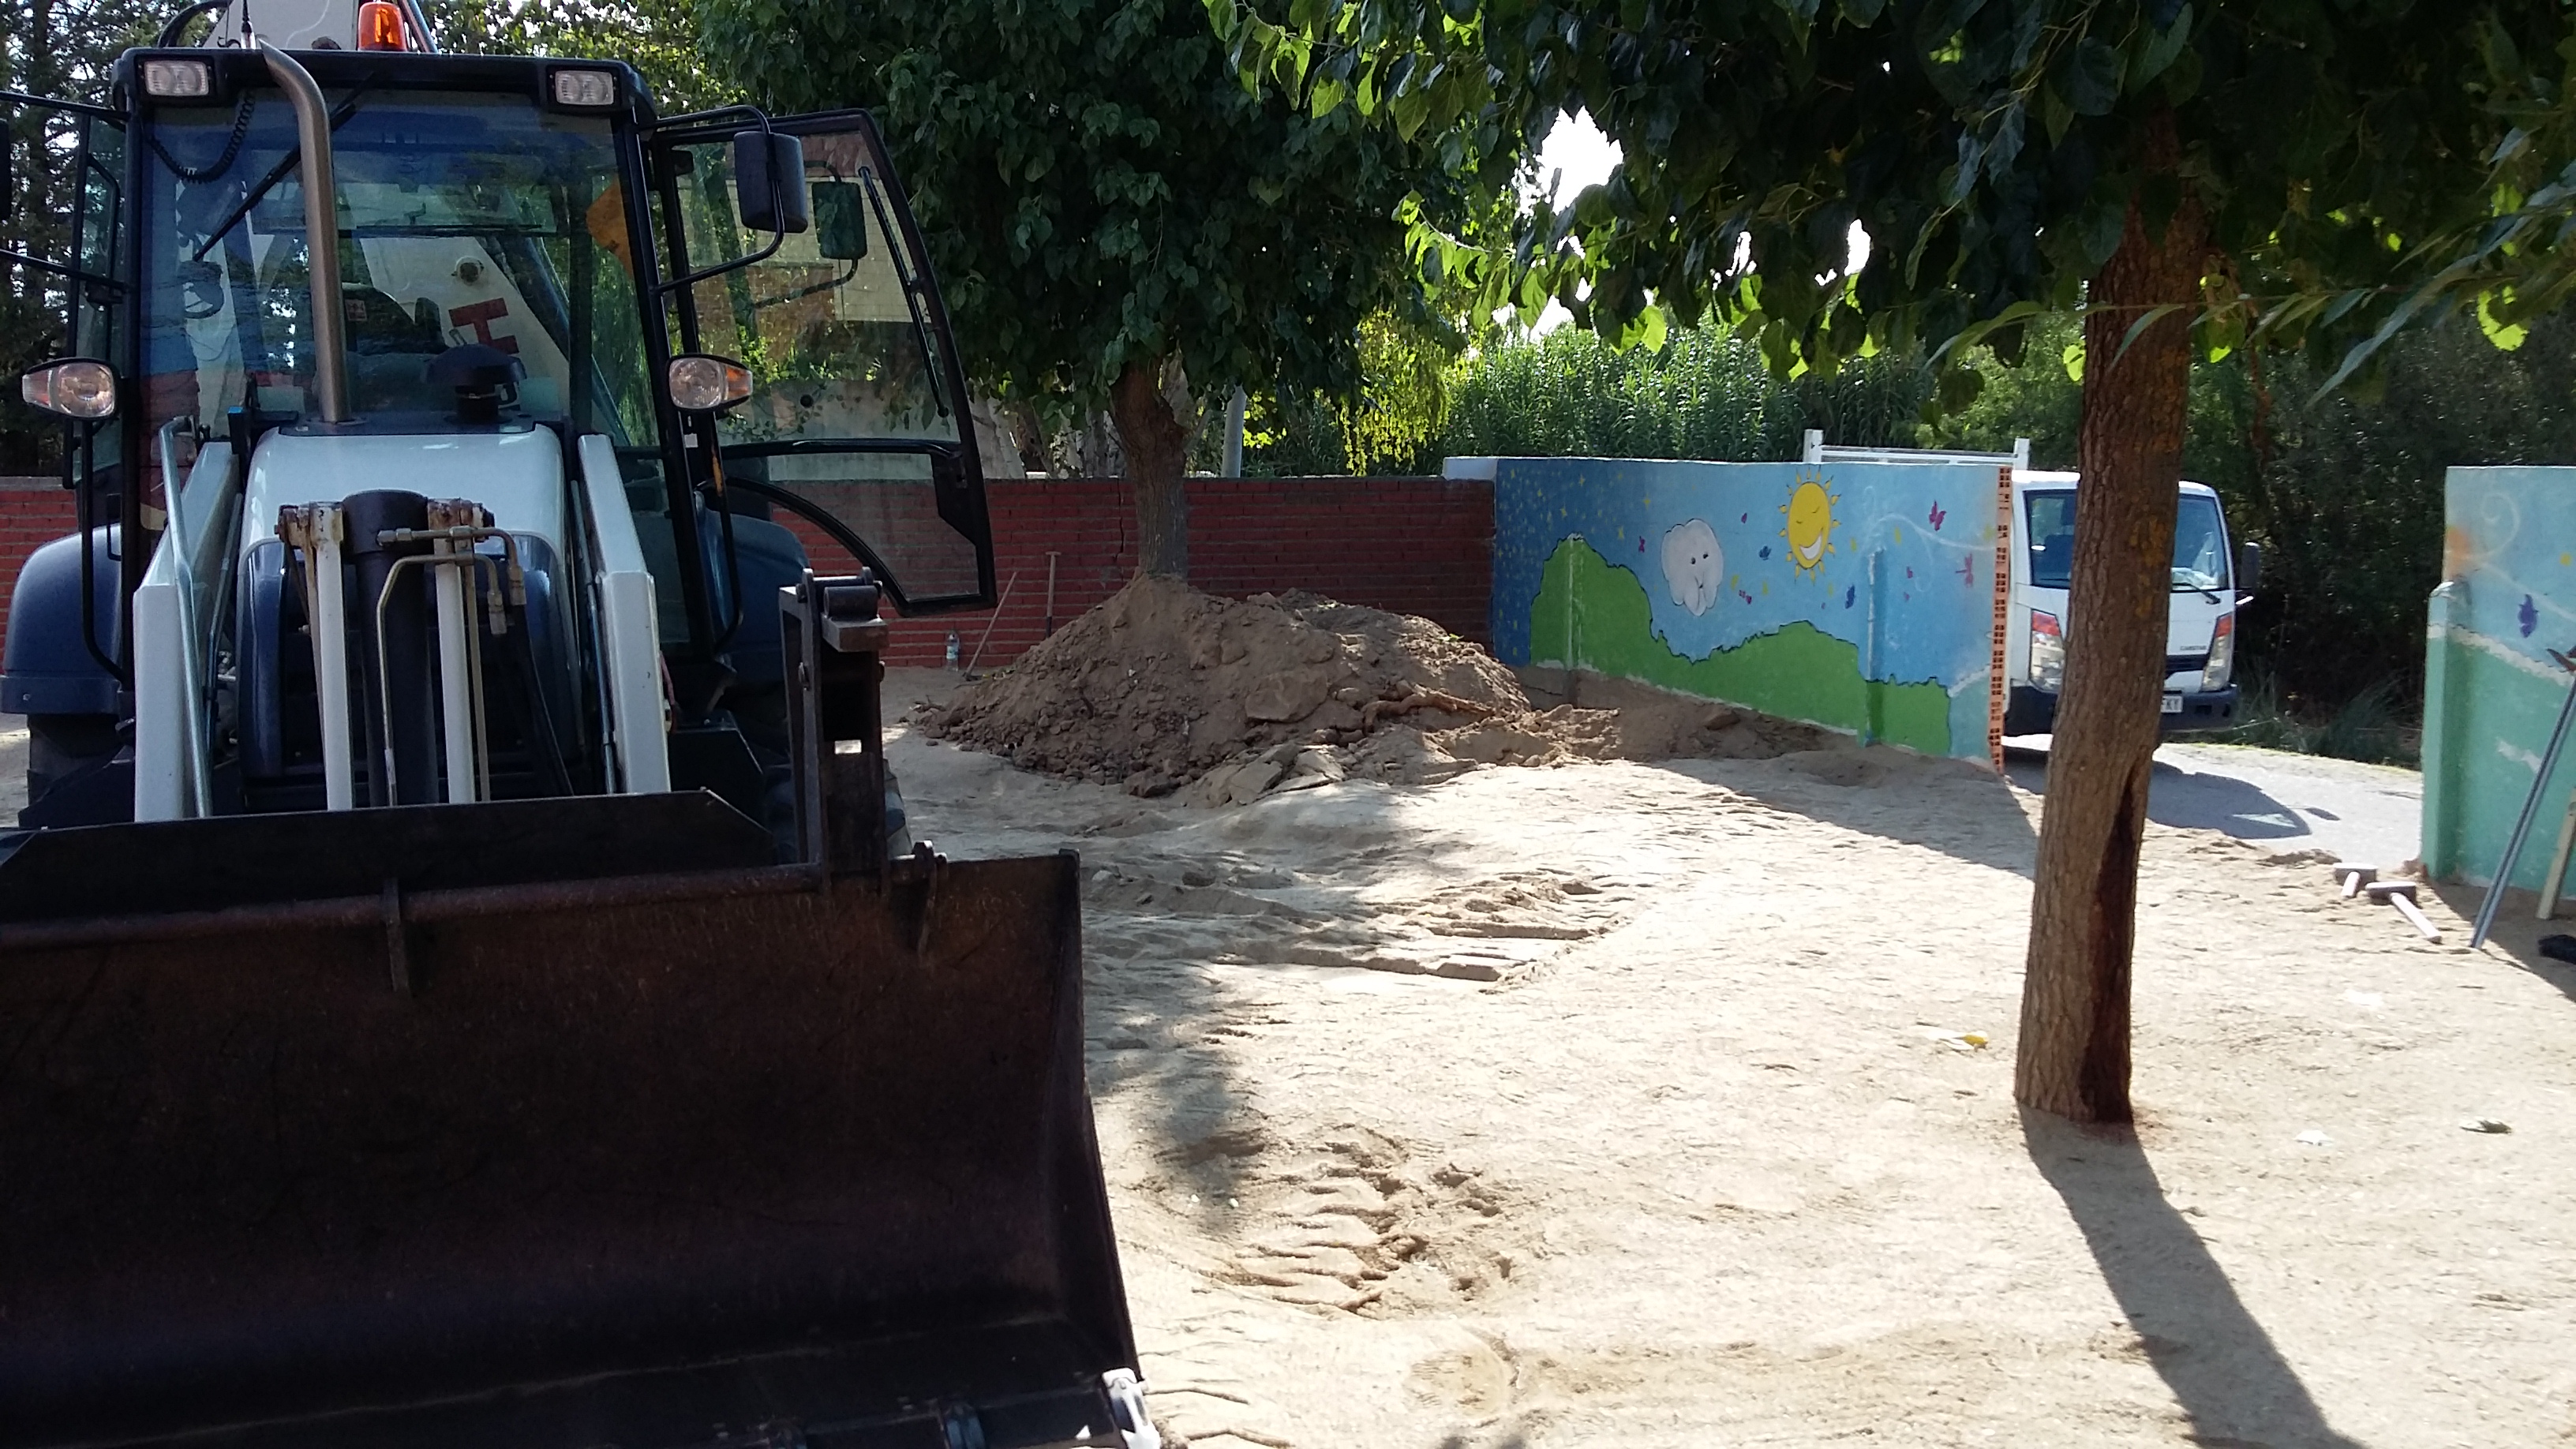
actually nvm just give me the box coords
[919,578,1829,804]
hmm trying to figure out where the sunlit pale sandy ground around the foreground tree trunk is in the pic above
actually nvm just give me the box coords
[894,678,2576,1449]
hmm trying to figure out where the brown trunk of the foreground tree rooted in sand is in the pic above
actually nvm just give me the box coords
[2012,114,2207,1121]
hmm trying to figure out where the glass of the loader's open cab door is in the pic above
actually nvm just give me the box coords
[675,121,982,601]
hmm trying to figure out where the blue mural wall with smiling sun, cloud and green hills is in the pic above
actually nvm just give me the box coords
[1494,459,1997,761]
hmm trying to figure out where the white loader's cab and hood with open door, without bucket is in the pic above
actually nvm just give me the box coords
[0,20,992,825]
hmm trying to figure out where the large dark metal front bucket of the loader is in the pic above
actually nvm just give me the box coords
[0,796,1136,1449]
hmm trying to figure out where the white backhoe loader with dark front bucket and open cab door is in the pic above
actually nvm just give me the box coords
[0,0,1157,1449]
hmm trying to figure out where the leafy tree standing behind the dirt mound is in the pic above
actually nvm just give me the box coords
[706,0,1473,575]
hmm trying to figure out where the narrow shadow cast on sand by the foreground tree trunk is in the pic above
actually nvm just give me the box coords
[2022,1109,2360,1449]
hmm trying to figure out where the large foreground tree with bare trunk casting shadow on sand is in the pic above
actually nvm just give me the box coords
[1208,0,2576,1121]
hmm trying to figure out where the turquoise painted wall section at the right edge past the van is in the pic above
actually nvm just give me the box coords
[2424,466,2576,889]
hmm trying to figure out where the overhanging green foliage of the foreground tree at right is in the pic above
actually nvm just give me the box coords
[1208,0,2576,394]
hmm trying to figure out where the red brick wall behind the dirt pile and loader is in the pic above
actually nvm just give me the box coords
[0,477,1494,668]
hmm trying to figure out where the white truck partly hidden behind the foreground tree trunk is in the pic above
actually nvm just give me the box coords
[1806,431,2262,735]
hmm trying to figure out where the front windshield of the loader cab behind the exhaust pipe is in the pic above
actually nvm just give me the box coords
[139,90,654,441]
